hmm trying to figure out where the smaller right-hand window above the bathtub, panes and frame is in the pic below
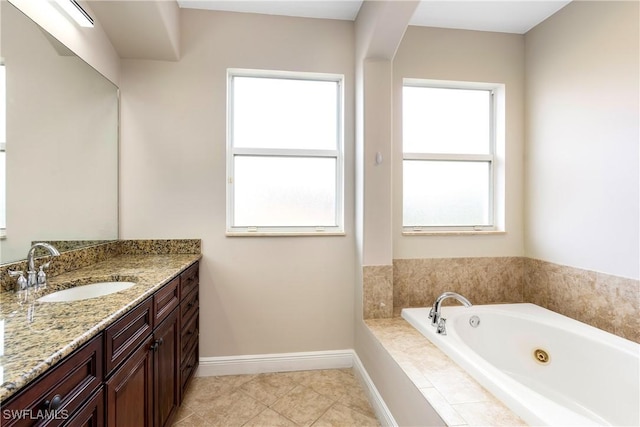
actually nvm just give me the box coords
[402,79,496,232]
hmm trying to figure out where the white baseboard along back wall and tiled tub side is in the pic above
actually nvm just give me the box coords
[196,349,397,427]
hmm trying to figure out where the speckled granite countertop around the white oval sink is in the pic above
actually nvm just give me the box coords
[0,254,201,402]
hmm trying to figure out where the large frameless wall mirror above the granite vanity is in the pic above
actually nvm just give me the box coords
[0,1,119,264]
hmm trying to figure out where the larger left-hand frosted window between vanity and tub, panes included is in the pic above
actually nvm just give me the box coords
[227,70,343,235]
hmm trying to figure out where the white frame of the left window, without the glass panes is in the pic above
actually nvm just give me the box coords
[226,68,345,237]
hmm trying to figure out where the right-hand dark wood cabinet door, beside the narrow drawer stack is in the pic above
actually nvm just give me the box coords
[153,309,180,427]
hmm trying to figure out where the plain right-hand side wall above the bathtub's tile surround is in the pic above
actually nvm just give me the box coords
[525,1,640,279]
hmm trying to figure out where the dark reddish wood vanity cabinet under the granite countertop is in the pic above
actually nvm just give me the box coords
[0,262,199,427]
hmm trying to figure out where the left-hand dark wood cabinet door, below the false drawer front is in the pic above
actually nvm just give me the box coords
[106,335,153,427]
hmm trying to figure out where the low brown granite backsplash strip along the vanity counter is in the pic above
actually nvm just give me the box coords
[0,239,201,292]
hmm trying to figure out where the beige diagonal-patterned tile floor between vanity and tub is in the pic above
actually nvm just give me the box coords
[173,369,380,427]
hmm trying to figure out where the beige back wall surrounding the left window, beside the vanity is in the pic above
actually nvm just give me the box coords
[121,10,356,357]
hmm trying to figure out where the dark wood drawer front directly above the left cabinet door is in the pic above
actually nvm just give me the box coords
[104,297,153,376]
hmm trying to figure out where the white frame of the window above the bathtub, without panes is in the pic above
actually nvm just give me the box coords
[402,78,504,235]
